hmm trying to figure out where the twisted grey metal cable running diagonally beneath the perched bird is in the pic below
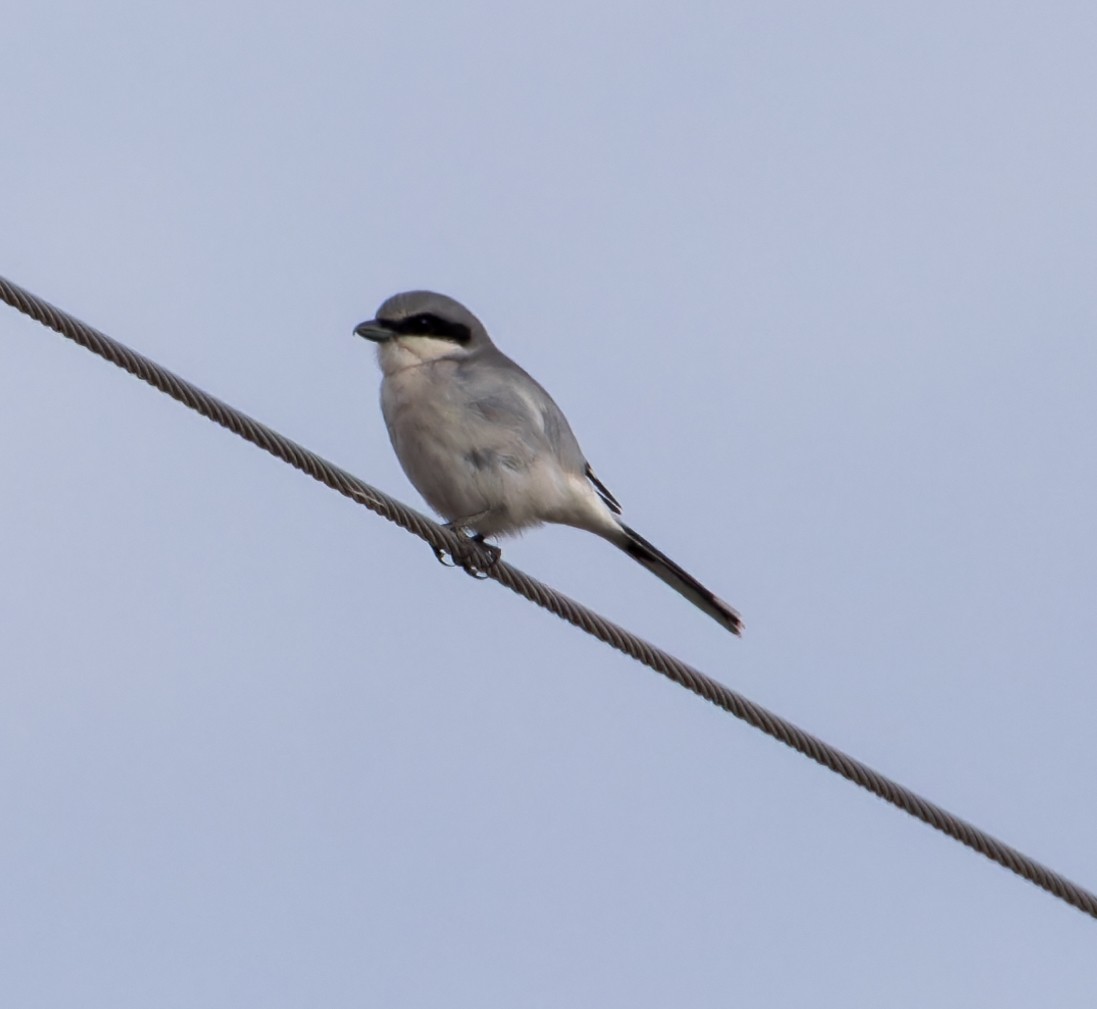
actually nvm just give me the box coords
[0,276,1097,918]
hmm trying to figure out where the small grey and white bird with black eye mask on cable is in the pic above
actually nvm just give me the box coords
[354,291,744,635]
